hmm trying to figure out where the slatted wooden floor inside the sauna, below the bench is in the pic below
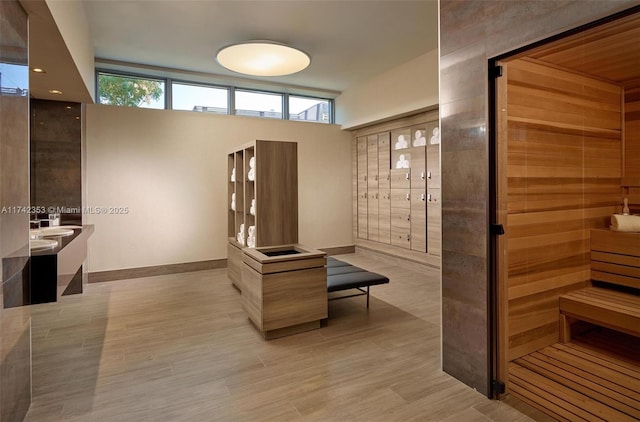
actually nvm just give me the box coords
[509,328,640,422]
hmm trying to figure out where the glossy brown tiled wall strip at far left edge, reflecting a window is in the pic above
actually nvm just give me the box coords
[0,0,31,422]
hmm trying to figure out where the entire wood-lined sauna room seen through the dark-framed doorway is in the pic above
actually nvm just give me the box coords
[492,9,640,421]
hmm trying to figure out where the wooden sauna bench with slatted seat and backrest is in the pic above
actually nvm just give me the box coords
[559,229,640,343]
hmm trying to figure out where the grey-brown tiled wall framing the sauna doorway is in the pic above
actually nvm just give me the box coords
[440,0,640,395]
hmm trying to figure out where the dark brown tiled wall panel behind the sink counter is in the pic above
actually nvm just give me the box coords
[31,100,82,222]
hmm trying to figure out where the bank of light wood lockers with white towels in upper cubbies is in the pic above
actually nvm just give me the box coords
[353,112,441,266]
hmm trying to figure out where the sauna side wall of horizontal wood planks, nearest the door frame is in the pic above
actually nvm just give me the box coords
[502,59,622,359]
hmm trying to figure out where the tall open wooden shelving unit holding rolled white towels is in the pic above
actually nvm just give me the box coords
[227,140,298,289]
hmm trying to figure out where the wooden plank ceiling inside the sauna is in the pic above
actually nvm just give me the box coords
[526,13,640,87]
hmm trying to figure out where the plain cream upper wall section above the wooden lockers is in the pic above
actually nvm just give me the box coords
[335,50,439,129]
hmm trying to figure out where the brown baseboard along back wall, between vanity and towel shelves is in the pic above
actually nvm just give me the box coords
[89,259,227,283]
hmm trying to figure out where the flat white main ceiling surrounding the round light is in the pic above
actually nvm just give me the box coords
[22,0,438,102]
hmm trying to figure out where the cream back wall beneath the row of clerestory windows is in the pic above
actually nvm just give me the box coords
[85,105,353,272]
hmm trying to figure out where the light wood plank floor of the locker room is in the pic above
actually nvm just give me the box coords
[26,253,544,422]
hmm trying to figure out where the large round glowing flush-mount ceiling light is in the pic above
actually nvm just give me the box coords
[216,41,311,76]
